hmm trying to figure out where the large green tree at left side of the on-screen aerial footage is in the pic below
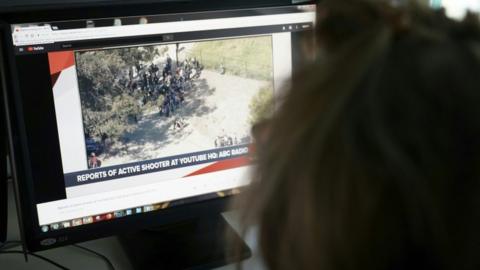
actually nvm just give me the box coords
[76,46,168,139]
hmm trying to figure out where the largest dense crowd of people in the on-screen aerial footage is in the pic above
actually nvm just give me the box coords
[124,57,203,117]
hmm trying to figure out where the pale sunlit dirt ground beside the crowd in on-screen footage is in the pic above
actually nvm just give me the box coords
[99,70,269,166]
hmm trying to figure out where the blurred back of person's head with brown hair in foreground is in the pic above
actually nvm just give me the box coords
[240,0,480,270]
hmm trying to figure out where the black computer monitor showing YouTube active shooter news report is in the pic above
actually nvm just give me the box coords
[3,1,315,255]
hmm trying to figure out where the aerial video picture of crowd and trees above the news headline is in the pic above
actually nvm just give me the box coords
[75,36,273,169]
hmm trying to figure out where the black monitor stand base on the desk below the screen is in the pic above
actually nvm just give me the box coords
[119,214,251,269]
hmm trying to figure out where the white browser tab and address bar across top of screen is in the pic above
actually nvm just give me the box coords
[12,11,315,46]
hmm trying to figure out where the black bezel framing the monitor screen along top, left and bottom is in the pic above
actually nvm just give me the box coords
[0,0,316,251]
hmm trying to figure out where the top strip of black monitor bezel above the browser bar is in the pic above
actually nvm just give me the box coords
[0,0,317,24]
